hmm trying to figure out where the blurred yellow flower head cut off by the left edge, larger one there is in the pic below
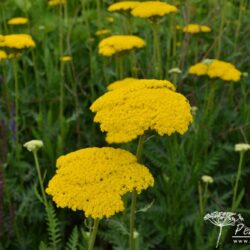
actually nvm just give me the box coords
[0,34,36,49]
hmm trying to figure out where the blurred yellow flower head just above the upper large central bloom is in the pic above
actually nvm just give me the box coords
[98,35,146,56]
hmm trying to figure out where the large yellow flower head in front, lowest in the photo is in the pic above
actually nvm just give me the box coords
[46,147,154,219]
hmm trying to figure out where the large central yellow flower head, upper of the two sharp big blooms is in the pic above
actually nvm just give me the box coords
[90,79,192,143]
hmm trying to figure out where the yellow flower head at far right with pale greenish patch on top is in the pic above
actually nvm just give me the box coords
[188,59,241,82]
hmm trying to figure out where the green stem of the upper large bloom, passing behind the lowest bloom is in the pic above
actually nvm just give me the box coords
[129,135,144,250]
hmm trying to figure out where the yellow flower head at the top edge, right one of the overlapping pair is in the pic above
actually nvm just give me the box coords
[131,1,177,18]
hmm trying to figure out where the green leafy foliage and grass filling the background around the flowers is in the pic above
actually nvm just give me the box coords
[0,0,250,250]
